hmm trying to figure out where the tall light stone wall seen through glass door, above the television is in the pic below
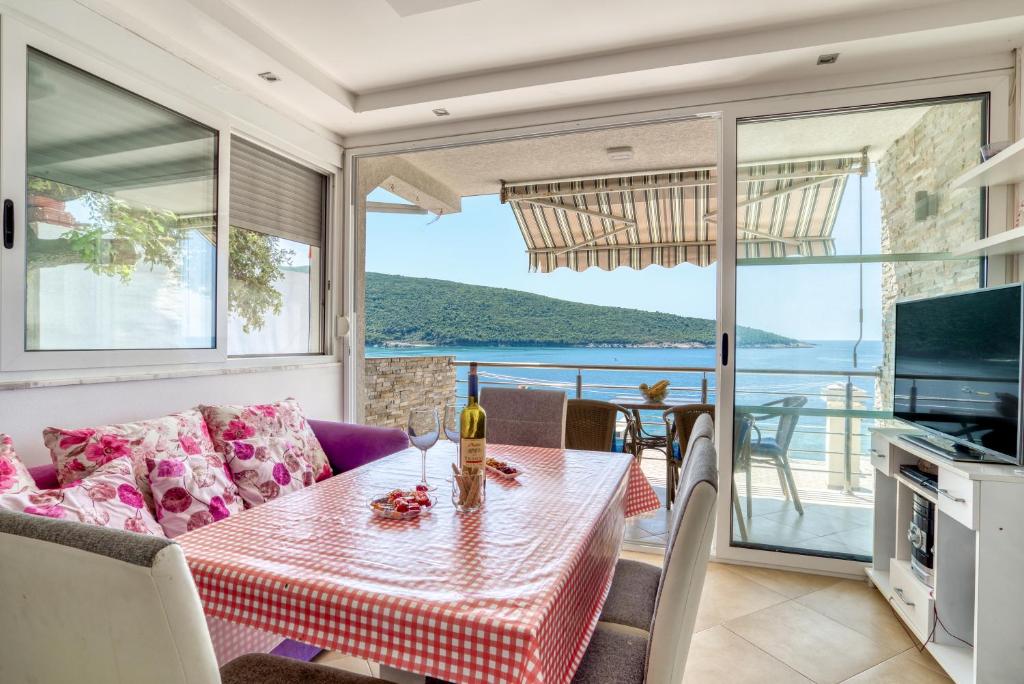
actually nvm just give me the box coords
[876,101,982,409]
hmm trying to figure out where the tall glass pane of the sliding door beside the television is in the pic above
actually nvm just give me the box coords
[732,97,986,560]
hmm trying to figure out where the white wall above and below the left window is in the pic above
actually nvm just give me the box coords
[0,0,343,465]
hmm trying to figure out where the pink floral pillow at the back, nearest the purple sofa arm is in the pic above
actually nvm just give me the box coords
[199,398,331,481]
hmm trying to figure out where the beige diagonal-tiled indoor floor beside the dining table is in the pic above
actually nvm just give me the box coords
[319,552,951,684]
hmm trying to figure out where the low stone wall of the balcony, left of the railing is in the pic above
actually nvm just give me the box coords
[364,356,455,428]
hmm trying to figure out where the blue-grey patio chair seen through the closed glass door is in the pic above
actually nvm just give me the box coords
[736,396,807,518]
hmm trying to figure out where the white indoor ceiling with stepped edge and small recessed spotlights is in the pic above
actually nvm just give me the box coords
[79,0,1024,136]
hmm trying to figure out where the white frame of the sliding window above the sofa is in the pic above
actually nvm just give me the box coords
[0,21,341,375]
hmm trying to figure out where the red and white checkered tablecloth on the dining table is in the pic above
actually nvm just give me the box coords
[182,442,659,683]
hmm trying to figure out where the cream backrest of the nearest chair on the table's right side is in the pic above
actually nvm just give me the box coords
[645,437,718,684]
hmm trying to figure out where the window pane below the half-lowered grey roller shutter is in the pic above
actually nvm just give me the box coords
[227,226,321,355]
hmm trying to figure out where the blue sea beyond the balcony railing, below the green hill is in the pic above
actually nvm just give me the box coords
[366,340,884,461]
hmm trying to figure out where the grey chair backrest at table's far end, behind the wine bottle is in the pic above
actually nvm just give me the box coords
[480,387,566,448]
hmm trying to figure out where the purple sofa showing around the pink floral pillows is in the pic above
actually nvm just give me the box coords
[29,420,409,661]
